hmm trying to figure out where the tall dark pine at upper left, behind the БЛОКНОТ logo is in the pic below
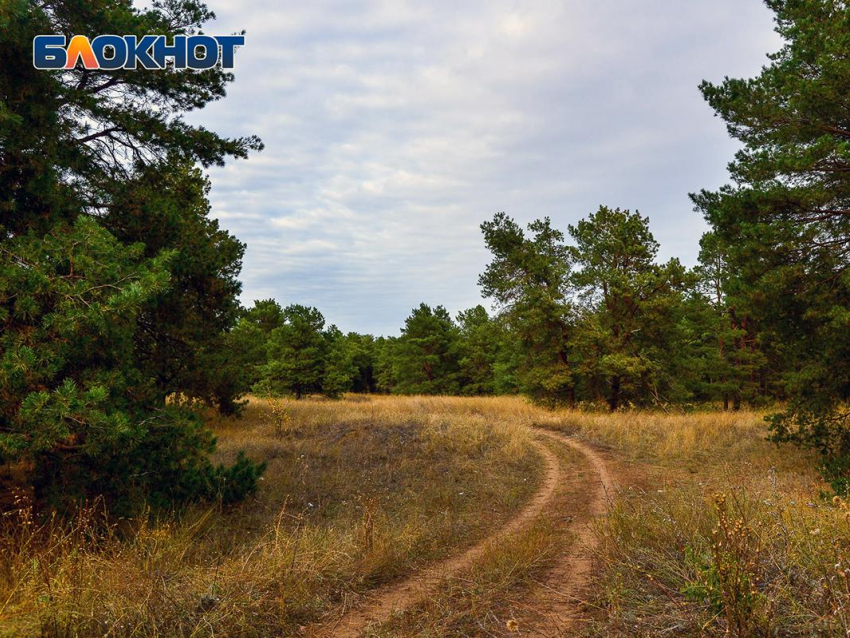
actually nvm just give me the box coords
[0,0,261,411]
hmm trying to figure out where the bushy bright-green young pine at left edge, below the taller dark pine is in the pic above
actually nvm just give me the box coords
[0,217,259,511]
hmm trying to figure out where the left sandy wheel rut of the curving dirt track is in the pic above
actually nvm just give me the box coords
[307,441,561,638]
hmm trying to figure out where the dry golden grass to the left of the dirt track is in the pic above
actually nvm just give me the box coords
[0,397,539,636]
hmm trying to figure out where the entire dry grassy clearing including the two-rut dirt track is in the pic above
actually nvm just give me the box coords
[0,395,850,636]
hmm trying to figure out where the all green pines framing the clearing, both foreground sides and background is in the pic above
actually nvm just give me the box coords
[0,0,850,513]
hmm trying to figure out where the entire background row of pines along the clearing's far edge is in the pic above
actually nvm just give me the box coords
[237,207,768,410]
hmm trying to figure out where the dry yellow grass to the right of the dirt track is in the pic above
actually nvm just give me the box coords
[541,412,850,637]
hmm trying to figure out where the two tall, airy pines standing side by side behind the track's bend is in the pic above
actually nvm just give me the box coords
[479,207,690,410]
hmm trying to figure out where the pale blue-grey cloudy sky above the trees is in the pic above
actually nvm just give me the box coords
[192,0,779,334]
